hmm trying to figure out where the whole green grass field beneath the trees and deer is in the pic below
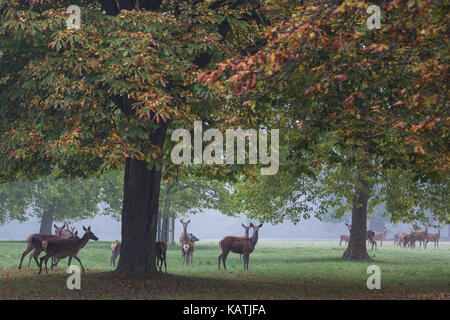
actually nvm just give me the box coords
[0,240,450,299]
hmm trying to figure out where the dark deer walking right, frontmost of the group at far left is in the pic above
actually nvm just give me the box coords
[38,226,98,275]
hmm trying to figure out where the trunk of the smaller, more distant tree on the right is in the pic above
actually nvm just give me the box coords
[342,169,371,261]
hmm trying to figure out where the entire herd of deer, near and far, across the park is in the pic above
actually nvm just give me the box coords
[18,219,441,274]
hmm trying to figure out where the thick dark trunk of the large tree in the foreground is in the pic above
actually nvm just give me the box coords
[117,124,167,274]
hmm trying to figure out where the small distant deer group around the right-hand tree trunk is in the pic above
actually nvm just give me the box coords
[339,223,441,250]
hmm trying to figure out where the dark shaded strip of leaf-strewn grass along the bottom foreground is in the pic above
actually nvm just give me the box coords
[0,269,450,300]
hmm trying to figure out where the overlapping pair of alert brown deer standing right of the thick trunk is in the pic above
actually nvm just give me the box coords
[217,223,263,270]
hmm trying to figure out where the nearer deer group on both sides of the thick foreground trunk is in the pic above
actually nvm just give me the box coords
[18,219,262,275]
